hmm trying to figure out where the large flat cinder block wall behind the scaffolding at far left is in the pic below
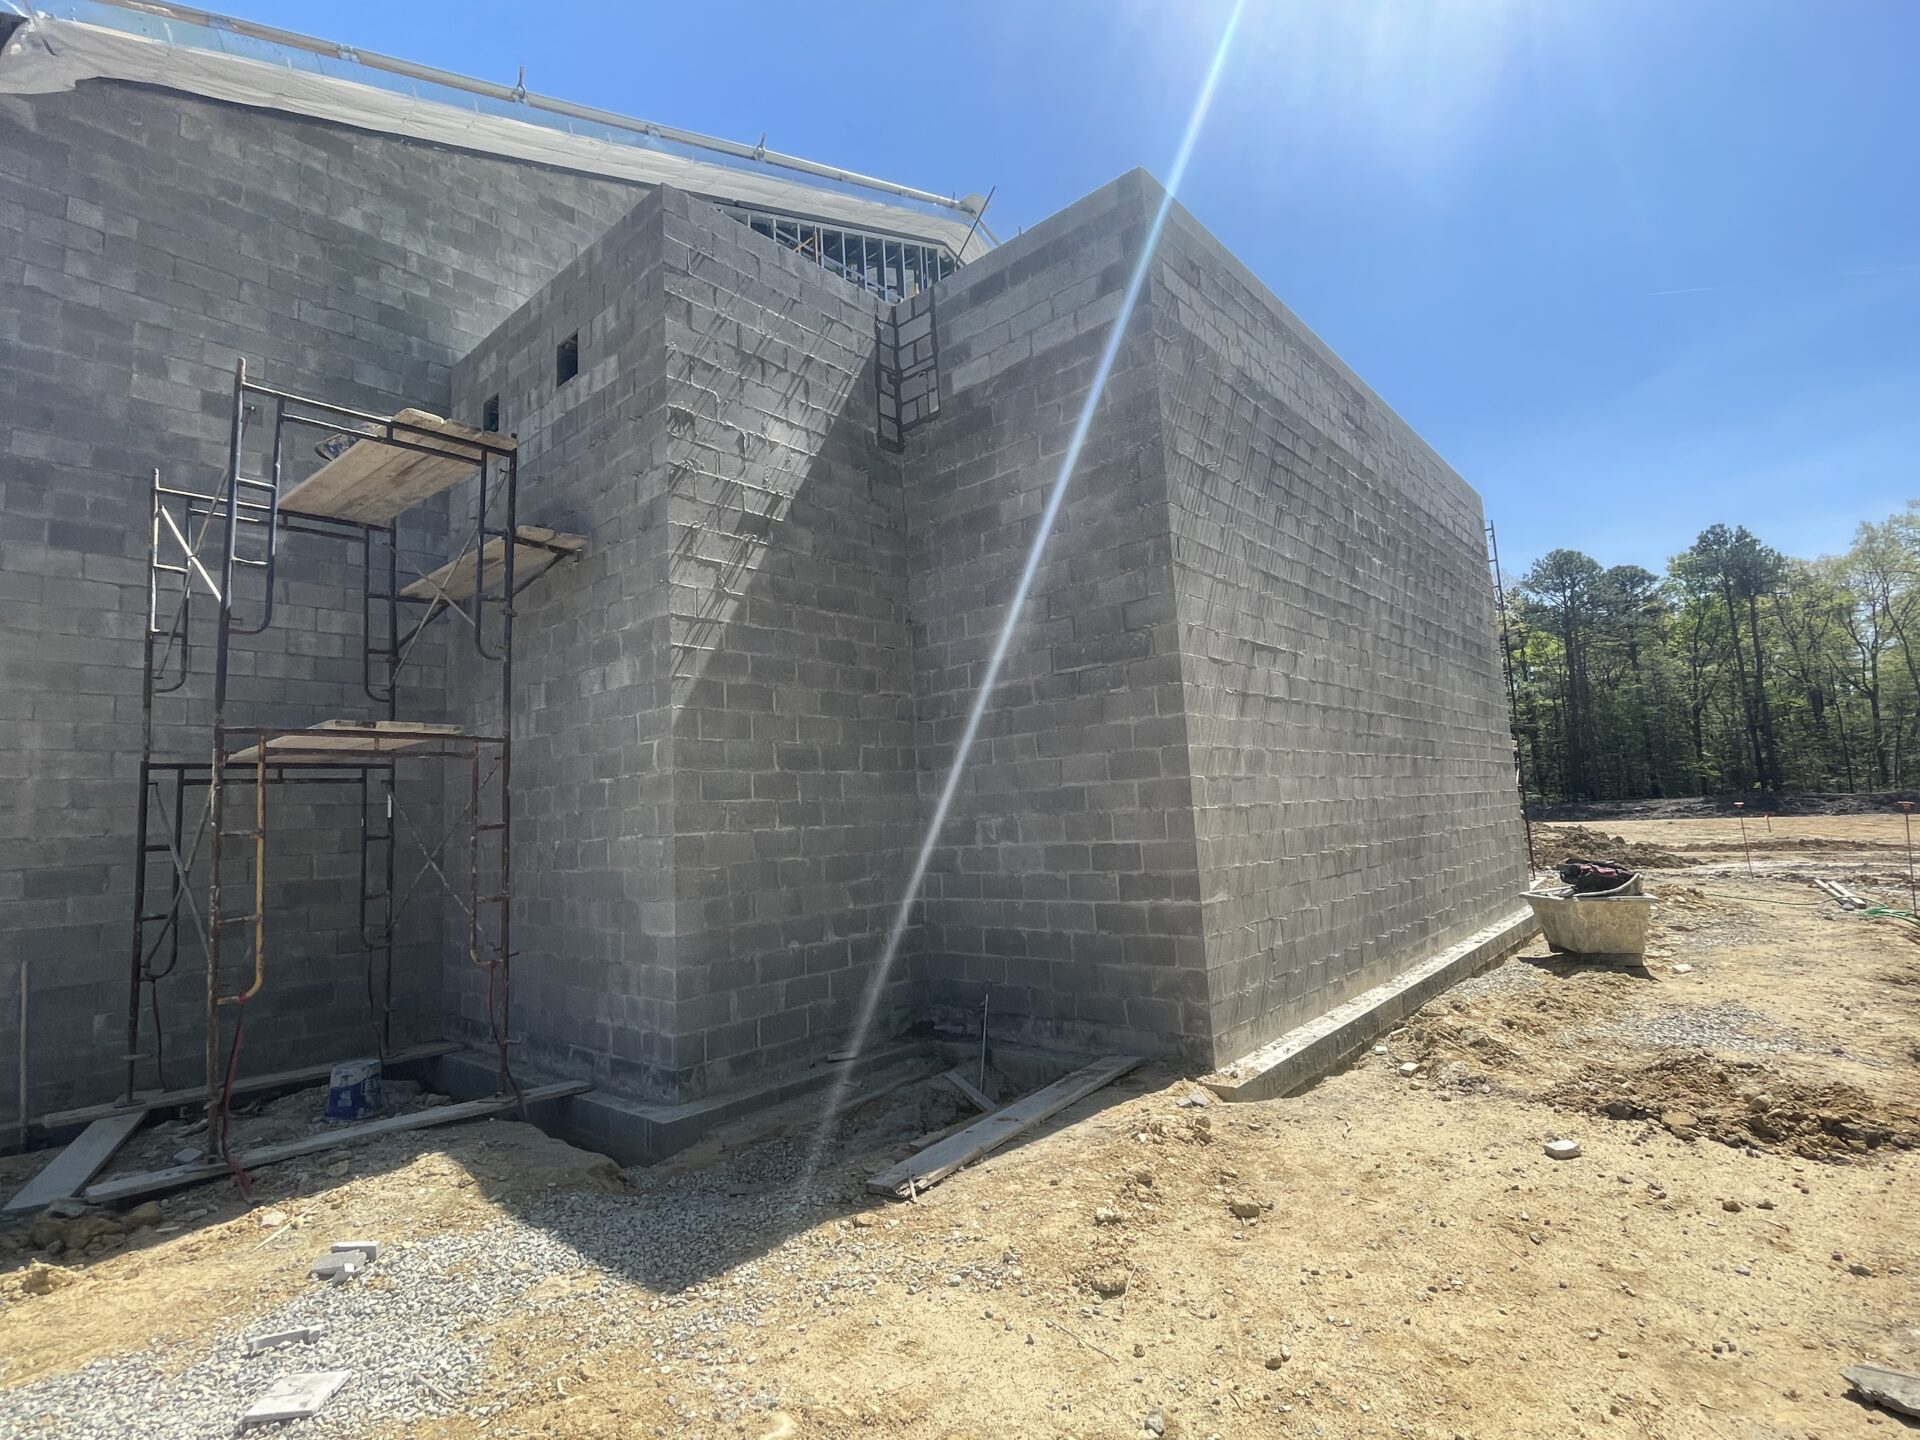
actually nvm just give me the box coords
[0,81,637,1114]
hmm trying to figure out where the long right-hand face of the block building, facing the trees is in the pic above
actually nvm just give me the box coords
[1152,197,1526,1062]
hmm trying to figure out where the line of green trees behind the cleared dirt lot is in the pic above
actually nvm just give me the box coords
[1503,501,1920,803]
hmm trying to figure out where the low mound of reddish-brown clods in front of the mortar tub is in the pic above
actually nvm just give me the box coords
[1540,1052,1920,1164]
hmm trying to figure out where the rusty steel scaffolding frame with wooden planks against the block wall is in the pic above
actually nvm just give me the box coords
[127,361,578,1158]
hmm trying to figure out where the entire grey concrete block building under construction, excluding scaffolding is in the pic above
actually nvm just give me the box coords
[0,0,1526,1136]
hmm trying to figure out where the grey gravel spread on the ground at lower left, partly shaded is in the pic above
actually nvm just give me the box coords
[0,1090,1021,1440]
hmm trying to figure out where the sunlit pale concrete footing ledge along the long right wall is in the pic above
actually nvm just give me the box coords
[1200,908,1540,1100]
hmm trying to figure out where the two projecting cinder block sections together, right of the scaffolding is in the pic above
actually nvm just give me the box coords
[439,171,1524,1098]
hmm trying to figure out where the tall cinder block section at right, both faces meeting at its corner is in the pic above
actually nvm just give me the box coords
[887,171,1524,1064]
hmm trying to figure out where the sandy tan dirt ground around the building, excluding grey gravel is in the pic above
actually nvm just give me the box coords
[0,816,1920,1440]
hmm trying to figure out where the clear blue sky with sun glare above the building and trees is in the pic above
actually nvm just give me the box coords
[215,0,1920,570]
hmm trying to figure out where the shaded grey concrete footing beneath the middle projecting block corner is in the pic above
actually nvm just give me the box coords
[430,1041,937,1165]
